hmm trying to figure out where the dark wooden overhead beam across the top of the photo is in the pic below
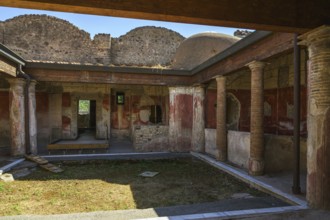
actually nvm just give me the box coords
[0,0,330,33]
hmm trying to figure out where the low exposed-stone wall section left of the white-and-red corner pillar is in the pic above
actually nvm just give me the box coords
[132,125,168,152]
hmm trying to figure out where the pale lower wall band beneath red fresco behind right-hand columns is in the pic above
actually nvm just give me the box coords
[205,129,307,172]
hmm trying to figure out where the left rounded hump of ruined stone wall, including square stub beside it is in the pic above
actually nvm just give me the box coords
[0,15,110,64]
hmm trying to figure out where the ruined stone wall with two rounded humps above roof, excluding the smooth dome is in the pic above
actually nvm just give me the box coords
[0,15,184,67]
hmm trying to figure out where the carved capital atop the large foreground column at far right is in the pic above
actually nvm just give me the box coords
[299,25,330,46]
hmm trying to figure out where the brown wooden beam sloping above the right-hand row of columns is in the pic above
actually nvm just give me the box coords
[192,33,294,83]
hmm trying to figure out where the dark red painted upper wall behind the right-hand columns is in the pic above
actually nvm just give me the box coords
[206,86,307,137]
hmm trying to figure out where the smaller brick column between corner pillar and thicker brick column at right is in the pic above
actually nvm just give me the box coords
[216,76,227,161]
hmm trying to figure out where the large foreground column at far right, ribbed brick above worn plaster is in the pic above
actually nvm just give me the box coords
[301,26,330,210]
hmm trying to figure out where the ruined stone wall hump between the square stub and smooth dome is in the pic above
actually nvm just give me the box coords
[111,27,184,66]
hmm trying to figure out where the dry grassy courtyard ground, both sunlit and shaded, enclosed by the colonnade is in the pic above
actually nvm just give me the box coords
[0,159,264,215]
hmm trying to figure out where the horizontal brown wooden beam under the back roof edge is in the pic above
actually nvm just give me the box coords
[24,68,191,86]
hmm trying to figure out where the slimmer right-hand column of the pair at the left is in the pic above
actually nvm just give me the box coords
[29,80,38,154]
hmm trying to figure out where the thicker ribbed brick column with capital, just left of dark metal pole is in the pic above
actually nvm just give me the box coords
[247,61,265,176]
